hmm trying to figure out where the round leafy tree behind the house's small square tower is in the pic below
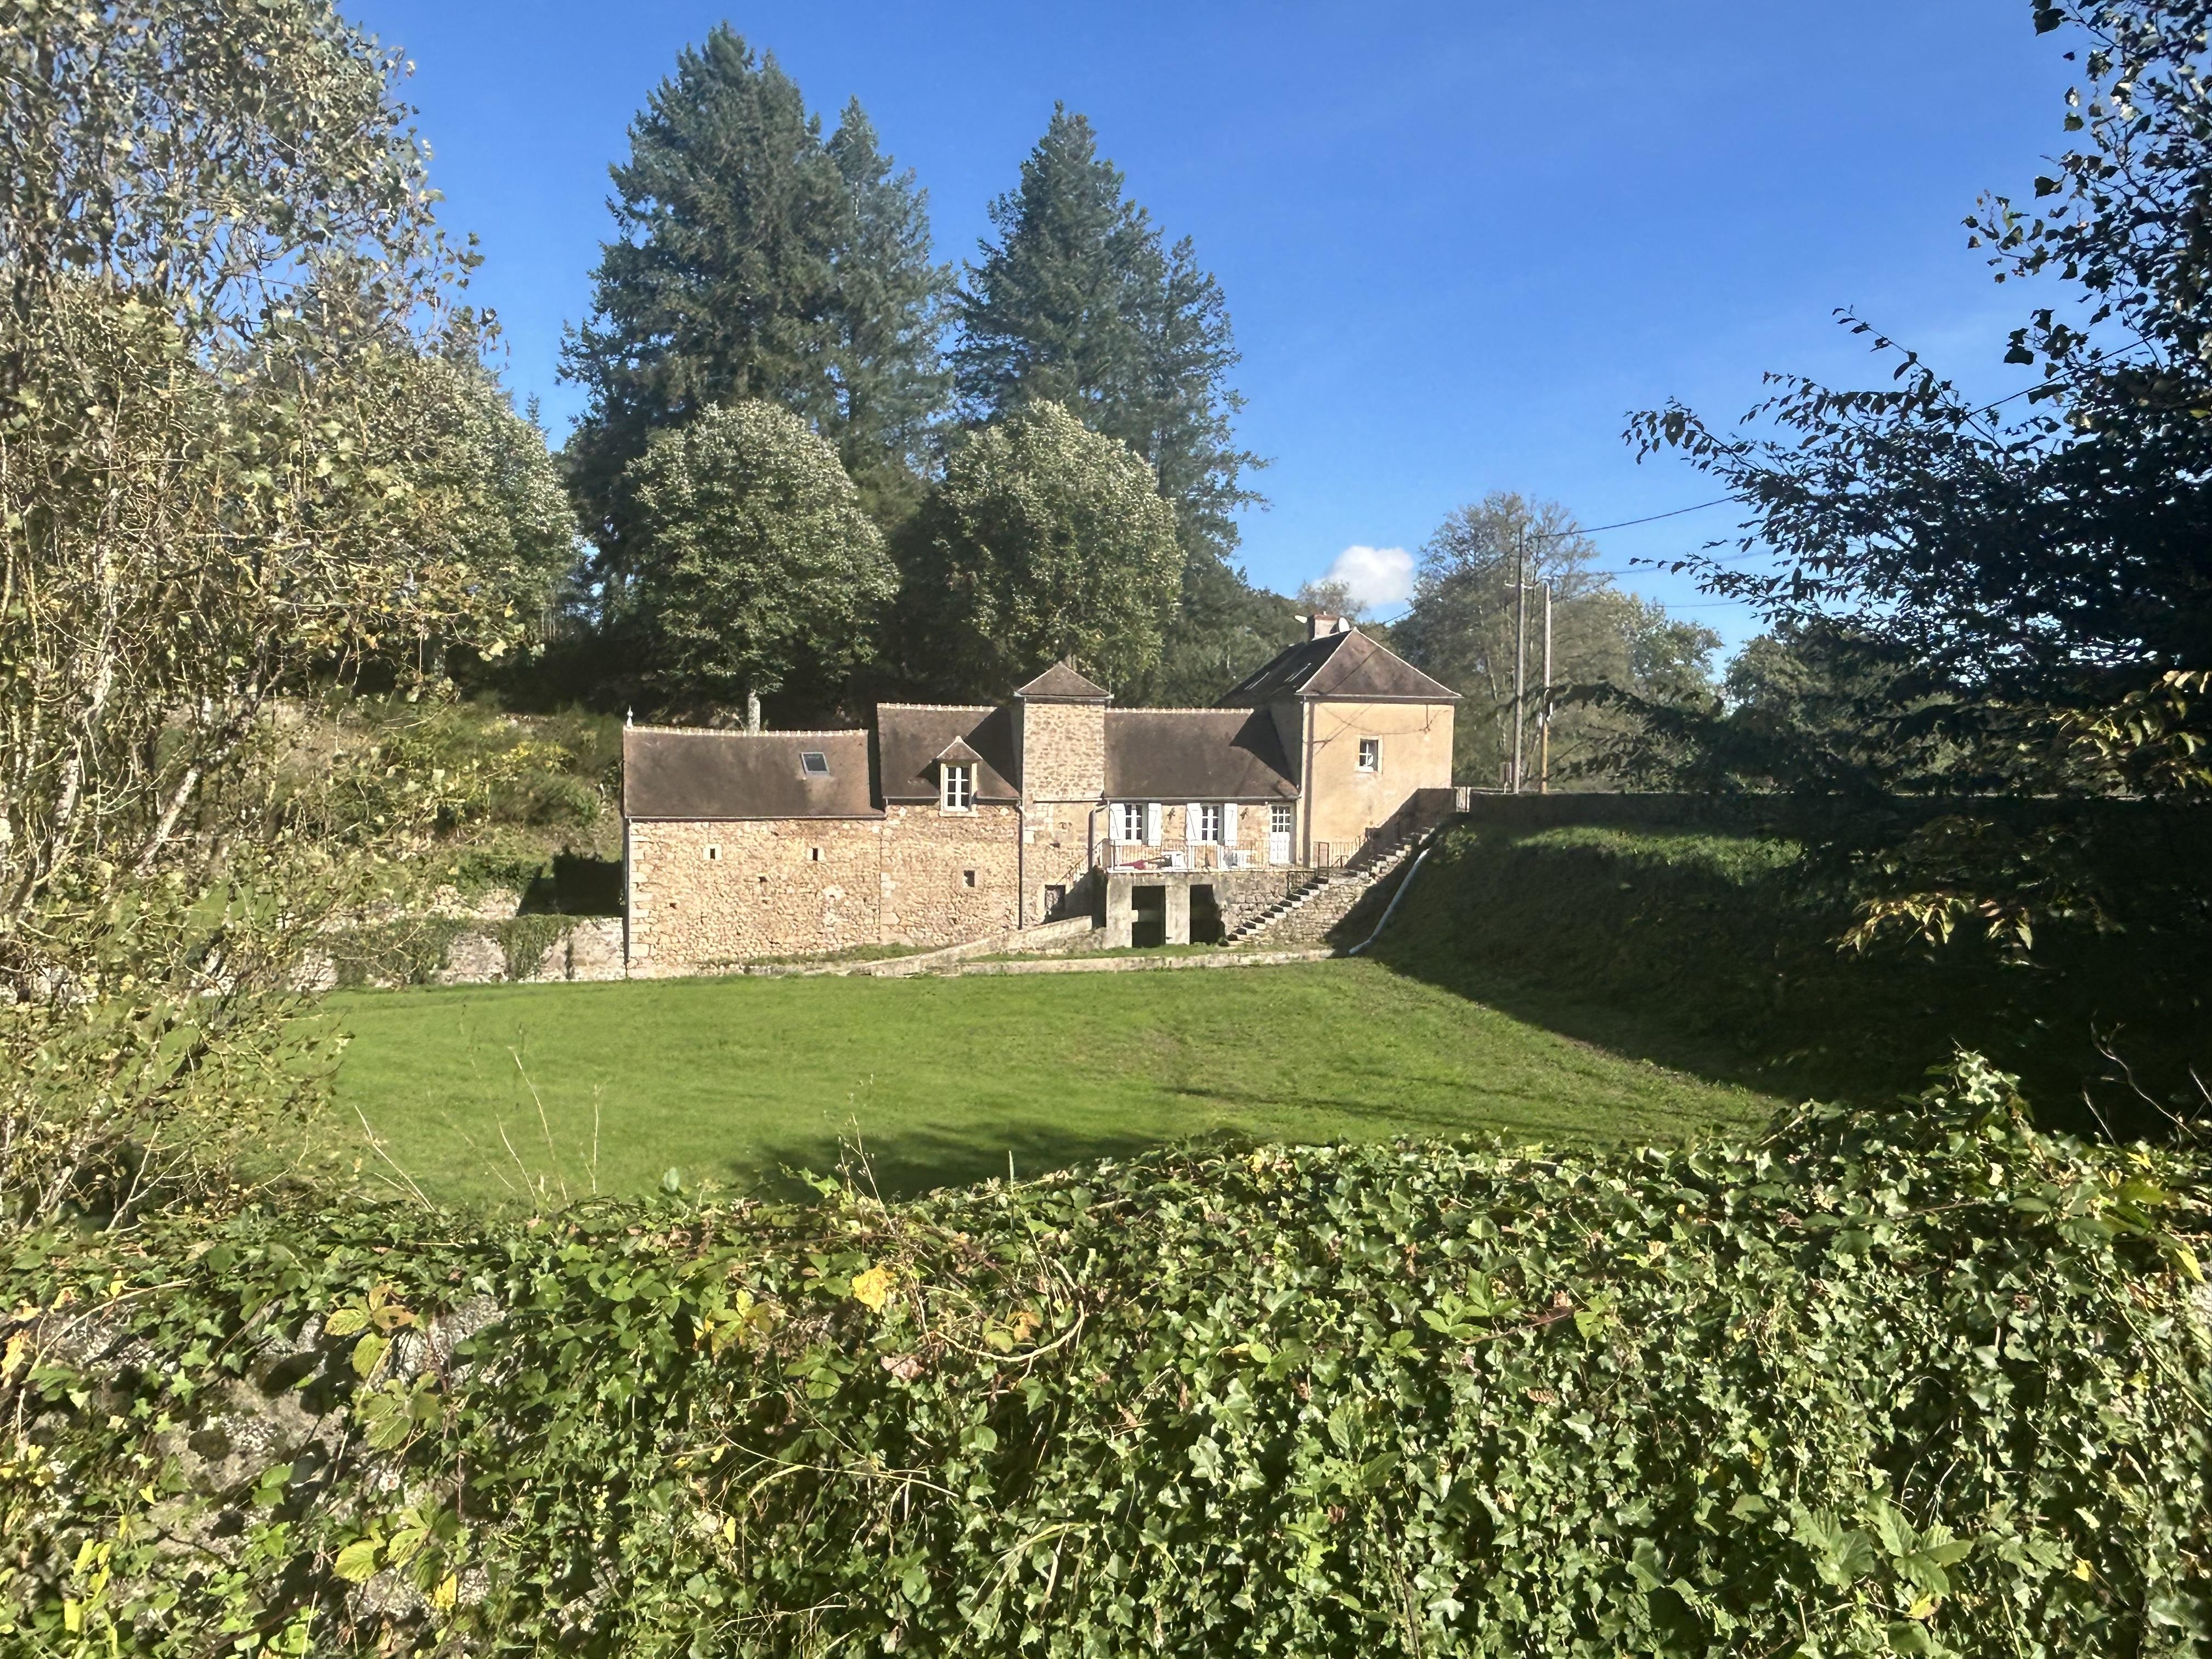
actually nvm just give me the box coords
[905,403,1181,695]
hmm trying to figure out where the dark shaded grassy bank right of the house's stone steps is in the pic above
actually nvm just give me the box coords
[1376,825,2212,1135]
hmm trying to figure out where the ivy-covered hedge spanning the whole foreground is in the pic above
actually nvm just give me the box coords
[0,1062,2212,1655]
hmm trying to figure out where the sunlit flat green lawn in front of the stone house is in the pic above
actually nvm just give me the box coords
[330,962,1772,1201]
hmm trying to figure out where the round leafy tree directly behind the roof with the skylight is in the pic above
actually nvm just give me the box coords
[628,400,898,728]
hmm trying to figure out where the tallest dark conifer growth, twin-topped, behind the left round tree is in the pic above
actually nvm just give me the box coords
[564,26,949,586]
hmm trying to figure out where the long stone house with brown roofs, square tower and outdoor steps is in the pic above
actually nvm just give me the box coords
[622,615,1458,975]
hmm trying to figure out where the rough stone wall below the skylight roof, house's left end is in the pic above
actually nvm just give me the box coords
[630,819,885,978]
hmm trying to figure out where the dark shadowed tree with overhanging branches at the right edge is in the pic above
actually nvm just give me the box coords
[1630,0,2212,789]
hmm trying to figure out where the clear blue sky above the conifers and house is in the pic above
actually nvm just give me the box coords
[347,0,2066,663]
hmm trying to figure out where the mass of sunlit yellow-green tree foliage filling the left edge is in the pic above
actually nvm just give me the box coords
[0,0,564,1217]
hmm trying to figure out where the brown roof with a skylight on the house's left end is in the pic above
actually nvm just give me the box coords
[622,725,881,819]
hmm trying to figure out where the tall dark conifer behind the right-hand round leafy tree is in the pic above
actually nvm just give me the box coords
[953,106,1290,701]
